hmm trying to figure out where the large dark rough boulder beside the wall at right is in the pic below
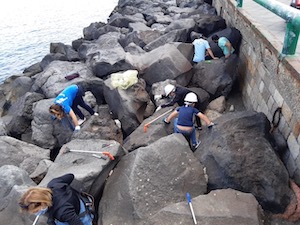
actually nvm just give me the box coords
[195,111,294,213]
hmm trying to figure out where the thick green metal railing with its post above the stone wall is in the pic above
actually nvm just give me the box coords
[253,0,300,55]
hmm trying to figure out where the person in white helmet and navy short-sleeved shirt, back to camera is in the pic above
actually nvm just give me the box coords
[163,92,215,151]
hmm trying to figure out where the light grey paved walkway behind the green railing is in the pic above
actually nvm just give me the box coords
[241,0,300,57]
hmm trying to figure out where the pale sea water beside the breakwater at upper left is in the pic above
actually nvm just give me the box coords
[0,0,118,83]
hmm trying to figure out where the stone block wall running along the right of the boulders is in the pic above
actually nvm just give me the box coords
[213,0,300,181]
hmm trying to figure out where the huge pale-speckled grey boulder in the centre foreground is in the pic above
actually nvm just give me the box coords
[98,134,206,225]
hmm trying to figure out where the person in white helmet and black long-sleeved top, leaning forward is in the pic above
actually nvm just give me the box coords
[159,84,202,130]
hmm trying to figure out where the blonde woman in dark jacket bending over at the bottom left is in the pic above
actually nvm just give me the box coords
[19,174,93,225]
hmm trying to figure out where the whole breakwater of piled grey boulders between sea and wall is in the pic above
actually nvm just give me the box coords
[0,0,299,225]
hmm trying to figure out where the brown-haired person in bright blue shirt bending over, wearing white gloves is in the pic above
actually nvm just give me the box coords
[49,84,98,131]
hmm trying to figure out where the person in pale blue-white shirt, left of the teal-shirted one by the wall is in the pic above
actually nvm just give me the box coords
[193,35,218,63]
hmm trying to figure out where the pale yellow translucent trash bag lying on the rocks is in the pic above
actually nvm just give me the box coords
[111,70,138,90]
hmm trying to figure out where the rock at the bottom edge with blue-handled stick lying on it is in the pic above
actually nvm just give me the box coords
[147,189,265,225]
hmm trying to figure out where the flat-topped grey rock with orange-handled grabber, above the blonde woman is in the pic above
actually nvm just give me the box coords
[39,139,125,201]
